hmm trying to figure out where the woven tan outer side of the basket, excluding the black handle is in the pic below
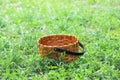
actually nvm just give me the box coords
[38,44,78,62]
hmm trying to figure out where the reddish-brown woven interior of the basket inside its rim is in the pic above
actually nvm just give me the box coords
[39,35,77,46]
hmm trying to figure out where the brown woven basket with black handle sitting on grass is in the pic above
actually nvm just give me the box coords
[37,35,85,62]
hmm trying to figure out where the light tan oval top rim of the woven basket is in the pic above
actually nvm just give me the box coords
[37,34,79,48]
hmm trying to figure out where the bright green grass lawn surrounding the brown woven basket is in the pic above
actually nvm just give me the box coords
[0,0,120,80]
